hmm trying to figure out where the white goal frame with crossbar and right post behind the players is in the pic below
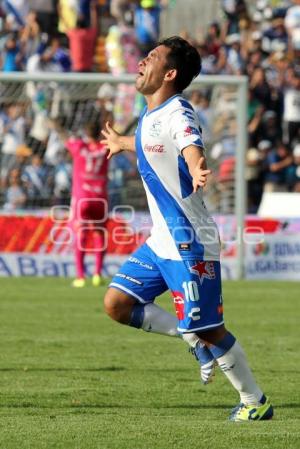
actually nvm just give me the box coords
[0,72,248,279]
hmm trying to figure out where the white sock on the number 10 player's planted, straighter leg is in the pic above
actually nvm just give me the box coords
[217,341,263,405]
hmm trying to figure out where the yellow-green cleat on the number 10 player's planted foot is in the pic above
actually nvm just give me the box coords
[229,395,273,422]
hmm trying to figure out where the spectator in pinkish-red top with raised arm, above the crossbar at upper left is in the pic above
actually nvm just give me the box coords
[65,0,98,72]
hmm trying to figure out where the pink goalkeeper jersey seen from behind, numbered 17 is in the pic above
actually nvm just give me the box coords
[66,138,108,200]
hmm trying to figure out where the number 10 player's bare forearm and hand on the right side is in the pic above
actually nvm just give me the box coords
[182,145,211,192]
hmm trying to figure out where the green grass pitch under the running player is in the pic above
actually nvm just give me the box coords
[0,278,300,449]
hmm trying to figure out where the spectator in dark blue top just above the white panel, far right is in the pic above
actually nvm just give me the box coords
[263,142,293,192]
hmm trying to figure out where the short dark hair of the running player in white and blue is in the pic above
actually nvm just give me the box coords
[158,36,201,92]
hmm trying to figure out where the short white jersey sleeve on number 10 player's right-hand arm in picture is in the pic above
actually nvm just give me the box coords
[170,105,204,153]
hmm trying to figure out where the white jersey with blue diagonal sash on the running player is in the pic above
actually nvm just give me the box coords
[136,95,220,261]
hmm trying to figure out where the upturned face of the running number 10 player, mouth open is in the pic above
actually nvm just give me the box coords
[135,45,170,95]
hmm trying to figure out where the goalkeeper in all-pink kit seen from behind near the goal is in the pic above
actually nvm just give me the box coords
[65,123,108,287]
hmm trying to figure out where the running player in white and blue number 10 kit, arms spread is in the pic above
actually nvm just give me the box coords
[102,37,273,421]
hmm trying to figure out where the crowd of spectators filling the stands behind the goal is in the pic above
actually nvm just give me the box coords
[0,0,300,212]
